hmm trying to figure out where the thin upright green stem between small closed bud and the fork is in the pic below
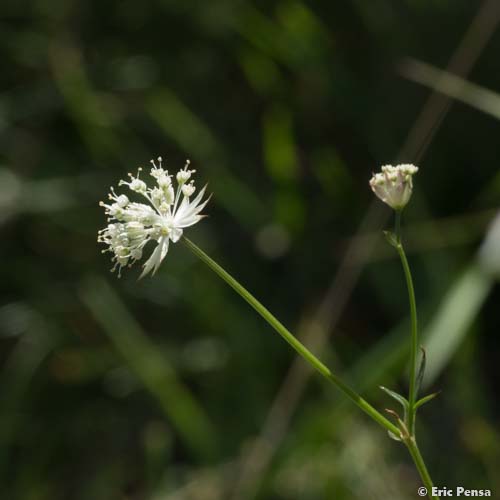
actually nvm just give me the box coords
[396,211,418,436]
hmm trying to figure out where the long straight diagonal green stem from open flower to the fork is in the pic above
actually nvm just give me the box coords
[182,236,400,436]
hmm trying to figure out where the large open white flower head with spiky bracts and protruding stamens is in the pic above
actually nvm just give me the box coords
[97,157,208,278]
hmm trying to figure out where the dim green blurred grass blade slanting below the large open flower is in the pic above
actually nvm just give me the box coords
[80,277,216,458]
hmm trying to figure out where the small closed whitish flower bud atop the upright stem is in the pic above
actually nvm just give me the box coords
[370,163,418,210]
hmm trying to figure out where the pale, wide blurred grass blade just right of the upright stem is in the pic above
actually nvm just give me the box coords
[423,264,493,387]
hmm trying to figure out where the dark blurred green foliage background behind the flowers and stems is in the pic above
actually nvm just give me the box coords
[0,0,500,500]
